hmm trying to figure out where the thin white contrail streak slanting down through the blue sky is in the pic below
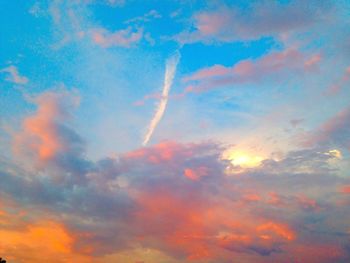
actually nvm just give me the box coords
[142,51,180,146]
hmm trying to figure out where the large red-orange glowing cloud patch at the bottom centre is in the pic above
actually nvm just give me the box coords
[135,180,296,260]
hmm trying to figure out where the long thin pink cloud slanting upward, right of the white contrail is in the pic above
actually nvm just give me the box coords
[183,49,320,92]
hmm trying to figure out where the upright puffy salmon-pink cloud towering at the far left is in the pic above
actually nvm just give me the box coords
[13,91,79,166]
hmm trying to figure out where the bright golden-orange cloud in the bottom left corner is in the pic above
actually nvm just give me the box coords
[0,207,93,263]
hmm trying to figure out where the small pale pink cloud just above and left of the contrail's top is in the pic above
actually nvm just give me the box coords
[91,26,143,47]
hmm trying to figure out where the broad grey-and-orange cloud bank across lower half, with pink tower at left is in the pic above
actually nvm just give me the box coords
[0,90,350,262]
